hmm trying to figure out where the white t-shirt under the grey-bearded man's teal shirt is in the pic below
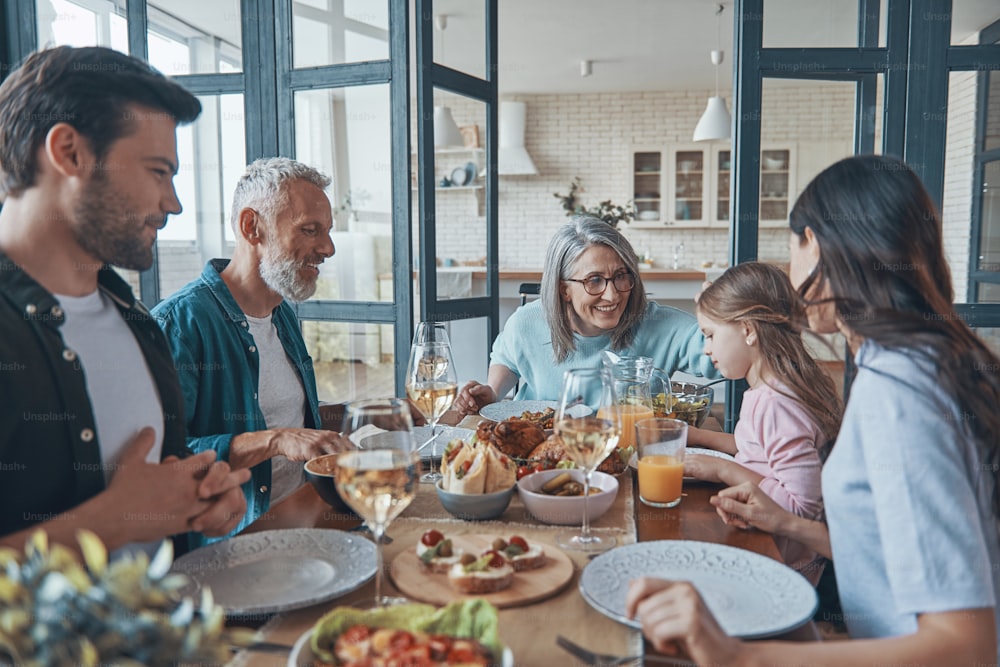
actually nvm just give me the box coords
[247,315,306,506]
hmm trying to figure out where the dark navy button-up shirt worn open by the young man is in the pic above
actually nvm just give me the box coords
[0,252,187,535]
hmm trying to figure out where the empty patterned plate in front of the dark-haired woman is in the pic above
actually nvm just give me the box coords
[580,540,819,639]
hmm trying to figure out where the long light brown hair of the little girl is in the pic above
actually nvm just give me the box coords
[698,262,844,460]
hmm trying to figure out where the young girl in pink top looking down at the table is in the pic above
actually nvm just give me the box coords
[684,262,843,584]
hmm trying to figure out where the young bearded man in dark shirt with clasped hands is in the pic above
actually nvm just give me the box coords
[0,47,248,549]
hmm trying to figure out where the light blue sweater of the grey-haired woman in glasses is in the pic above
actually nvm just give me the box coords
[490,300,720,401]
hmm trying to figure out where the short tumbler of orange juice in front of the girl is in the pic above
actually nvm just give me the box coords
[635,417,688,507]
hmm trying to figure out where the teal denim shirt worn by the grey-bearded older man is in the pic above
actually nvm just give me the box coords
[152,259,320,548]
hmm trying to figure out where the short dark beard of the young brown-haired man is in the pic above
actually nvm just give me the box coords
[73,171,166,271]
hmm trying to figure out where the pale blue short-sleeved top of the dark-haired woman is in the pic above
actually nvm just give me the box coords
[823,340,1000,638]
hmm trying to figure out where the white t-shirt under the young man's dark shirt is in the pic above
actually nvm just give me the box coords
[54,290,163,555]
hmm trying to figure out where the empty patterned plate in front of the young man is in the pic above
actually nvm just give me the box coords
[173,528,375,616]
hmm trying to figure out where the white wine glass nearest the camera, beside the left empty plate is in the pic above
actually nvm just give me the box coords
[336,398,420,608]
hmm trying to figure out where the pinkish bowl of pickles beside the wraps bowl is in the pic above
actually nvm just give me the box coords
[517,469,618,526]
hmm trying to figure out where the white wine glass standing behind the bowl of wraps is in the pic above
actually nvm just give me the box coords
[406,322,458,482]
